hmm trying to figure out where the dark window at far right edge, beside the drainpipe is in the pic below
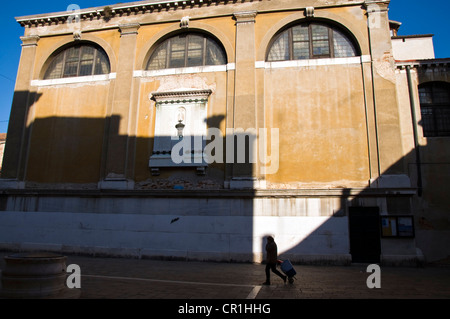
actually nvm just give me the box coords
[419,82,450,137]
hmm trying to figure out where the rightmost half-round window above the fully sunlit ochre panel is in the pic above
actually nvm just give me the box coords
[267,22,358,62]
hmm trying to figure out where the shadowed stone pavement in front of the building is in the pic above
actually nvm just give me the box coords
[0,252,450,300]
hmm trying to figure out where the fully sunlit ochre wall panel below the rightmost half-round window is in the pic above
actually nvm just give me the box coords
[265,64,369,187]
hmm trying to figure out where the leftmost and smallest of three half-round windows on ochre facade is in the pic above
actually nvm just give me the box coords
[44,43,110,80]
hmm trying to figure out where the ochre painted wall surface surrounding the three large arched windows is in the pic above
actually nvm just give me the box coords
[3,1,402,188]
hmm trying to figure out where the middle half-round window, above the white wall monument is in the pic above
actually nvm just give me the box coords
[147,33,226,70]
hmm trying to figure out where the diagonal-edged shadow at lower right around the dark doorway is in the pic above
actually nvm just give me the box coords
[274,118,450,265]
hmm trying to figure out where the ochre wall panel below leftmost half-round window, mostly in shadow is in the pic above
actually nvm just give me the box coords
[26,82,110,183]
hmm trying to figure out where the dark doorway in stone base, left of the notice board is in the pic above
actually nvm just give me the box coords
[349,207,381,263]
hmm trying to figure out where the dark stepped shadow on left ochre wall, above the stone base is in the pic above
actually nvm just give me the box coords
[3,112,236,189]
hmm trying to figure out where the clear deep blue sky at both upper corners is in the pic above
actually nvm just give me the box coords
[0,0,450,133]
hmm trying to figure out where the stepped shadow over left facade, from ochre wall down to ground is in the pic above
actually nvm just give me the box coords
[0,106,260,261]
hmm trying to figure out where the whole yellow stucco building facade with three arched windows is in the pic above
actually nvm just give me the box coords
[0,0,449,264]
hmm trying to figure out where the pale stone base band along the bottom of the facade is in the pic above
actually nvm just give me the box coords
[0,189,421,265]
